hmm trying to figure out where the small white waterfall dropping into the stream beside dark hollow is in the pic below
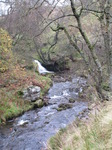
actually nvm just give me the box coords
[33,60,54,74]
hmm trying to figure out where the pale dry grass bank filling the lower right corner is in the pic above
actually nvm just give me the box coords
[48,102,112,150]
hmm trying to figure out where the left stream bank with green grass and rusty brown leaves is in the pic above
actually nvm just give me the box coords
[0,68,52,124]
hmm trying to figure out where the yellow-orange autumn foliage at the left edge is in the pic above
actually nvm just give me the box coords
[0,29,13,72]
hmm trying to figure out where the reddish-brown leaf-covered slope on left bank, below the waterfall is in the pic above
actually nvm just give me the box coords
[0,64,47,91]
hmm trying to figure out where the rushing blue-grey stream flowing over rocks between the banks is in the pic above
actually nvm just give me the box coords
[0,78,87,150]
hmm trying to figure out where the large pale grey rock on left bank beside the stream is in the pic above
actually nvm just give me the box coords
[23,86,41,102]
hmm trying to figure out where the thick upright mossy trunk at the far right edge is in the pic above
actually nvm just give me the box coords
[98,0,112,90]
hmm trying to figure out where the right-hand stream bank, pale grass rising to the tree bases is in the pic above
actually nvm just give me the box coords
[47,62,112,150]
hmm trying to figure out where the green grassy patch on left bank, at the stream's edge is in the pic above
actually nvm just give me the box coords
[0,89,33,123]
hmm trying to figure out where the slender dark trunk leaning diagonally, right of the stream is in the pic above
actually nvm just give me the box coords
[70,0,103,98]
